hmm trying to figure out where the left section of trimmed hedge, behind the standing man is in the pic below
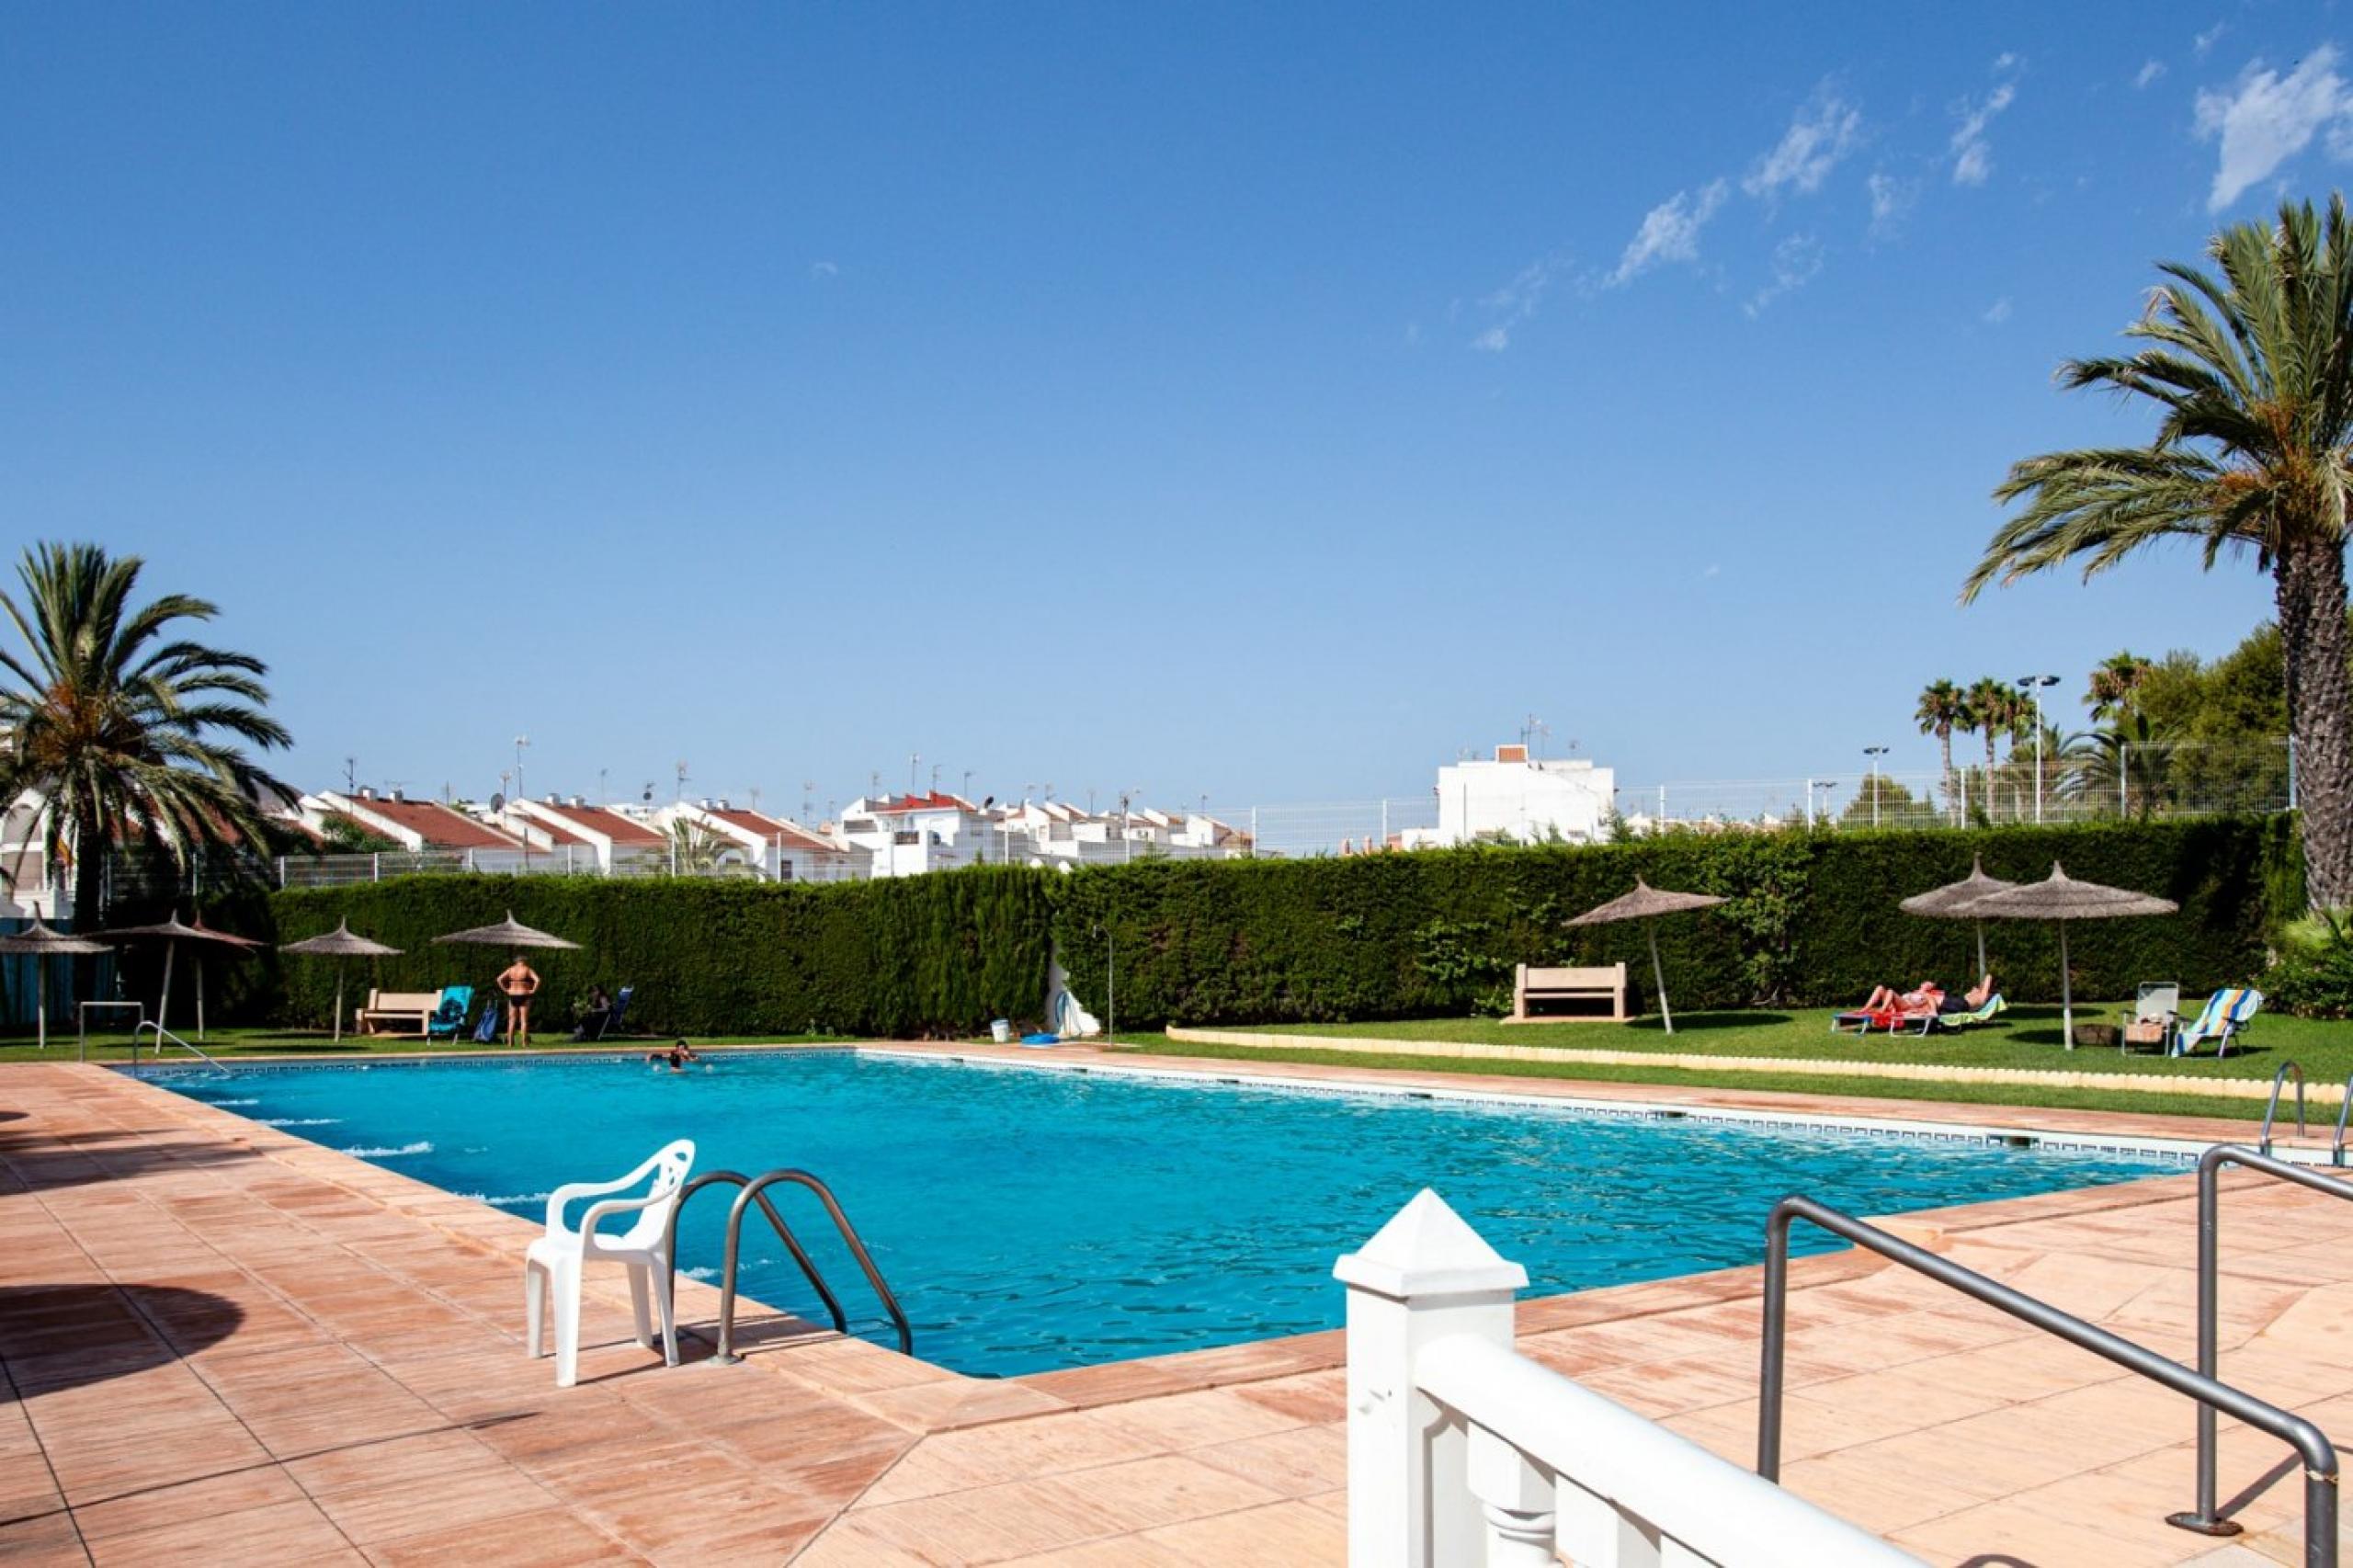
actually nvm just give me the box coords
[262,867,1051,1039]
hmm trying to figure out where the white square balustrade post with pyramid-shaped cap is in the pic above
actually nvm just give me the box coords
[1332,1189,1527,1568]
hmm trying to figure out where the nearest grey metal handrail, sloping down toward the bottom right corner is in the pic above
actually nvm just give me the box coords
[1757,1199,2336,1568]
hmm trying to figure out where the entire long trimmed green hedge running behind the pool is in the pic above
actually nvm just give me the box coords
[248,819,2302,1036]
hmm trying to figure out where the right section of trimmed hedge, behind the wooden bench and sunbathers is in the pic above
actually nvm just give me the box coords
[1056,819,2302,1027]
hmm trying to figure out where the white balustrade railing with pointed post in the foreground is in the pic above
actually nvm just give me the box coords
[1335,1189,1917,1568]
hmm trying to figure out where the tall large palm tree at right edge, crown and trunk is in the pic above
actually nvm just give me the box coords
[1960,196,2353,909]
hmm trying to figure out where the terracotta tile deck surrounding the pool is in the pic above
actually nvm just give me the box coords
[0,1048,2353,1565]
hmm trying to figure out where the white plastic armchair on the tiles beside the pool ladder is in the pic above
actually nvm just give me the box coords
[522,1137,694,1389]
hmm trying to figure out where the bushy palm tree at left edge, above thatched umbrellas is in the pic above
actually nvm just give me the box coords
[0,544,287,960]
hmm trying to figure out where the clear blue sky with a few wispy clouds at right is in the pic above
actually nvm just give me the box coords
[0,12,2353,810]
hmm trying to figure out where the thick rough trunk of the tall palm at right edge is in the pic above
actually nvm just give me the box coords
[2273,540,2353,909]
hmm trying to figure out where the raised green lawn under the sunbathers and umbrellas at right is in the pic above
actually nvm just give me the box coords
[1213,1003,2353,1083]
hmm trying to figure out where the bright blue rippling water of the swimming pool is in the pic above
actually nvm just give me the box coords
[152,1052,2163,1375]
